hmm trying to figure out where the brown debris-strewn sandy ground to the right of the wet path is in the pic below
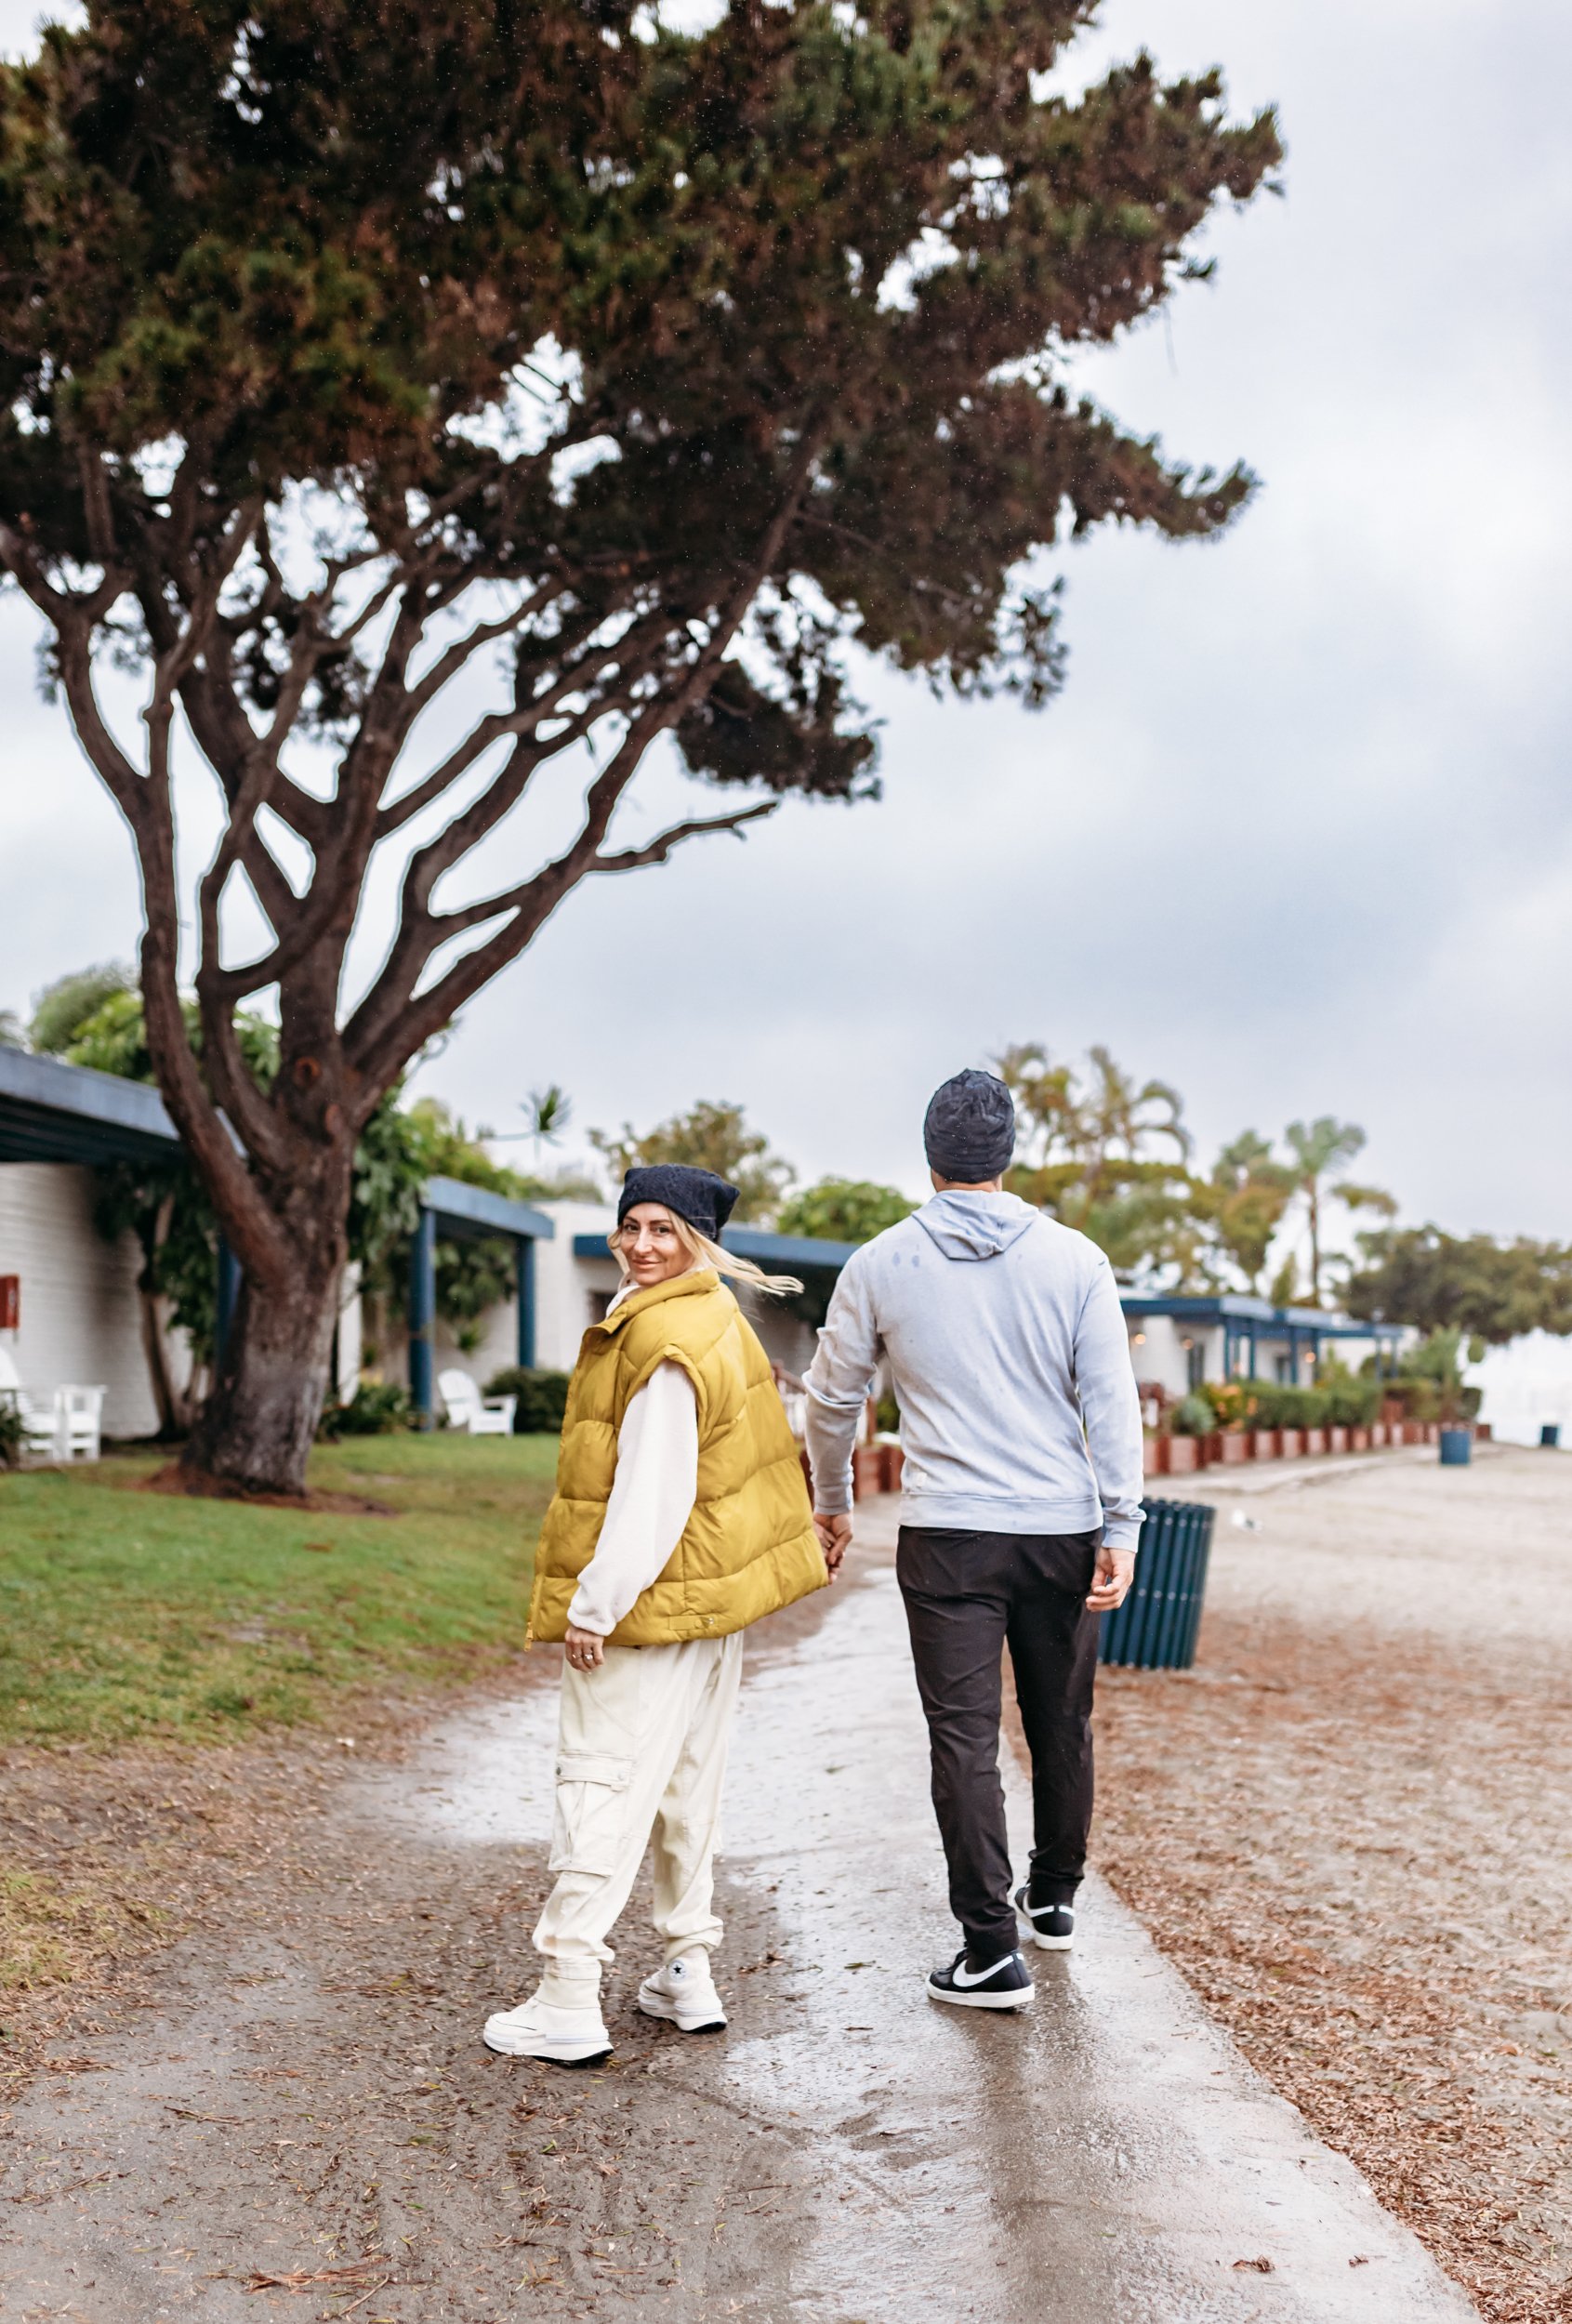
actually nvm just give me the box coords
[1093,1450,1572,2324]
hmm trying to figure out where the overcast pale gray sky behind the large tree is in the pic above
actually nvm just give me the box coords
[0,0,1572,1236]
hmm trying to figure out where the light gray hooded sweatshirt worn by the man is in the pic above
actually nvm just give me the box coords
[807,1190,1142,1551]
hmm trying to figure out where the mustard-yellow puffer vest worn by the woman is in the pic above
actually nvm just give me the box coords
[530,1267,828,1645]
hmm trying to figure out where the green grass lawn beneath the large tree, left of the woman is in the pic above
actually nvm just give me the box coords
[0,1434,556,1743]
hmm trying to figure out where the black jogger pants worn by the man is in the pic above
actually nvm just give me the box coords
[895,1525,1100,1960]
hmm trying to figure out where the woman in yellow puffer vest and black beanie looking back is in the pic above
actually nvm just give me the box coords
[483,1165,828,2067]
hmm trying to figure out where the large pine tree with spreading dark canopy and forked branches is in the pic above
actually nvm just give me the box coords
[0,0,1279,1490]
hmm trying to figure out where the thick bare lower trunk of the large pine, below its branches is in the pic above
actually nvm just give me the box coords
[184,1250,344,1492]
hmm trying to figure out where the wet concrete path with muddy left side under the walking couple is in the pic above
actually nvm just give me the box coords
[0,1520,1474,2324]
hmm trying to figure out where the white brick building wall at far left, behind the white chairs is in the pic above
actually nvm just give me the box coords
[0,1162,158,1436]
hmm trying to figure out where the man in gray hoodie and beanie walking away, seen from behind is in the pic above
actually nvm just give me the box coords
[807,1072,1144,2011]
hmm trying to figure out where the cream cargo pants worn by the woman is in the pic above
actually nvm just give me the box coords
[535,1631,742,1985]
